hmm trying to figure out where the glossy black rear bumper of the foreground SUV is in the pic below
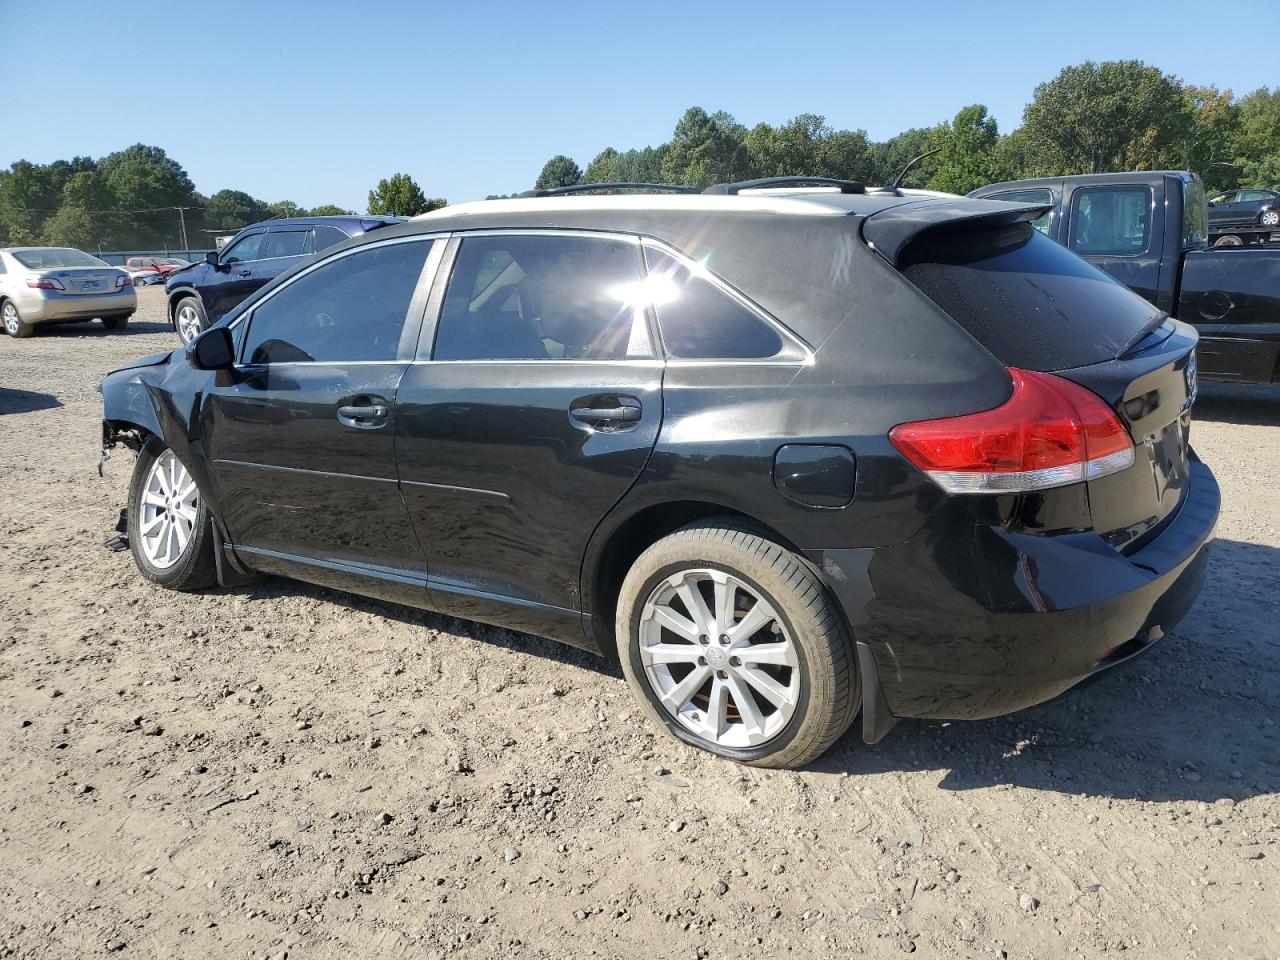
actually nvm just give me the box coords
[822,461,1220,719]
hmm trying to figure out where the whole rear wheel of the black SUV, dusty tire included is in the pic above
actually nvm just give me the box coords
[616,520,861,768]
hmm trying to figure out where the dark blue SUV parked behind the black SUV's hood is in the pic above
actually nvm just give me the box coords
[165,216,402,343]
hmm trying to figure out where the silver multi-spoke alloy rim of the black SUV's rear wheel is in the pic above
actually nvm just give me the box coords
[640,568,800,748]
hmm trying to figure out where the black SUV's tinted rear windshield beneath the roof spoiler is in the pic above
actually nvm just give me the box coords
[901,223,1158,370]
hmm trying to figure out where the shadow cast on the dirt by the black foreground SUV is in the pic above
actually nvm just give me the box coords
[212,540,1280,803]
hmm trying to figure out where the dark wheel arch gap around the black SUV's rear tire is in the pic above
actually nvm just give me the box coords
[581,499,804,662]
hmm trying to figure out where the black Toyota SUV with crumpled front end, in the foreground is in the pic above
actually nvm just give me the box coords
[102,183,1219,767]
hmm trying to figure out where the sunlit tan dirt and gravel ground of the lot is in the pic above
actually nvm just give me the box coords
[0,288,1280,960]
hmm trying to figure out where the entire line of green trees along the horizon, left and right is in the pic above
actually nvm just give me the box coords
[0,60,1280,250]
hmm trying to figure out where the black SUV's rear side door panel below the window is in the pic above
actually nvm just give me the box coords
[394,361,662,620]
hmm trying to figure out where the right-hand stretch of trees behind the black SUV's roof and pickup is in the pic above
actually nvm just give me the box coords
[527,60,1280,196]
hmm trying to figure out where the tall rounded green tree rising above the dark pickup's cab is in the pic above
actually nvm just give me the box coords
[1023,60,1194,174]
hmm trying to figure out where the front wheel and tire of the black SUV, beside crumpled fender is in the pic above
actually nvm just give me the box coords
[129,438,218,590]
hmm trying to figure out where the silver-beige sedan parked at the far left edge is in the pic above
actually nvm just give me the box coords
[0,247,138,337]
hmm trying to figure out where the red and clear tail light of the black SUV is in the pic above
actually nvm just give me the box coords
[888,367,1134,493]
